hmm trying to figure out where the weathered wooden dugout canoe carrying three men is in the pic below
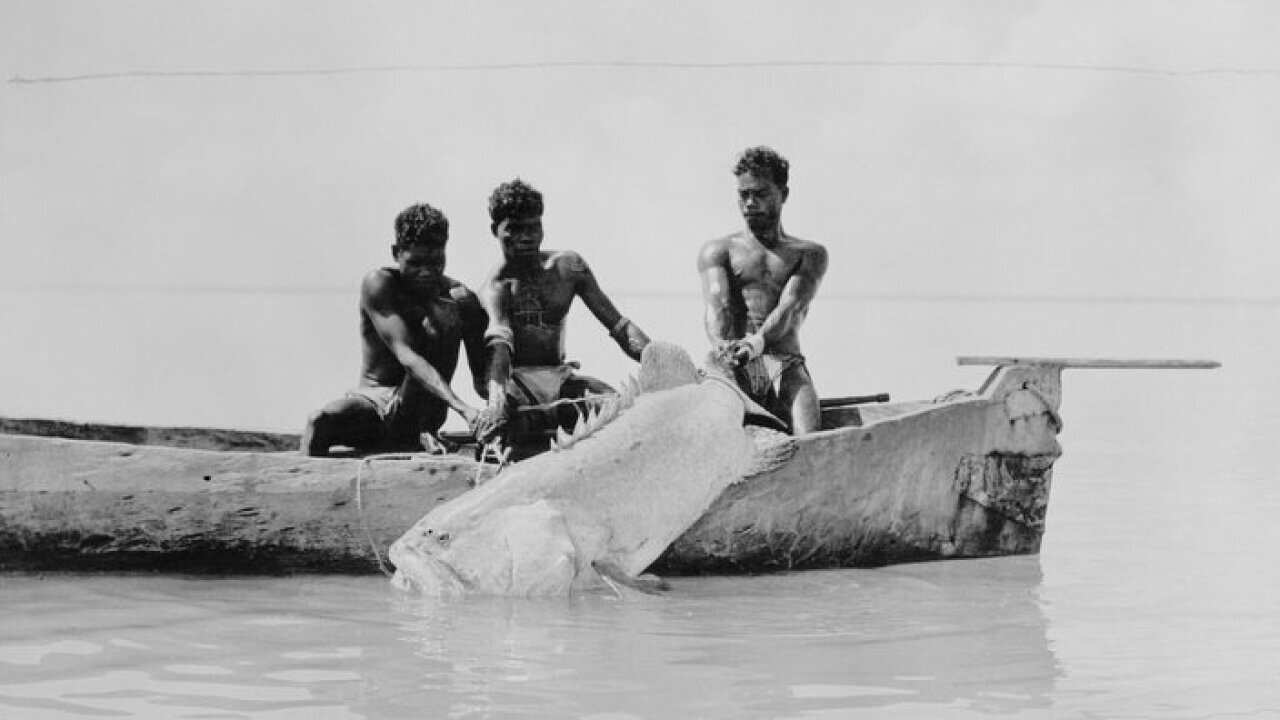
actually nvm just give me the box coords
[0,357,1217,574]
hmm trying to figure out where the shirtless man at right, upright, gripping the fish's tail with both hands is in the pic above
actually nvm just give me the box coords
[698,147,827,434]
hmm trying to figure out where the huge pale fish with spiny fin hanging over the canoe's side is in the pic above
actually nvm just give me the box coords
[389,342,794,596]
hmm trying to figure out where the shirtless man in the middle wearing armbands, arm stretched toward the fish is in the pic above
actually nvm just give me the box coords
[479,178,649,436]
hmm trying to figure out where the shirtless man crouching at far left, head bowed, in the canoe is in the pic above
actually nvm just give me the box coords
[301,205,486,455]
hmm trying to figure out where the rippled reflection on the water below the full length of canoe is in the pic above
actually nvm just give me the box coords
[0,557,1059,717]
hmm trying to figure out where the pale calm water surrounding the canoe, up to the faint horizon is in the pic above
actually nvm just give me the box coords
[0,295,1280,719]
